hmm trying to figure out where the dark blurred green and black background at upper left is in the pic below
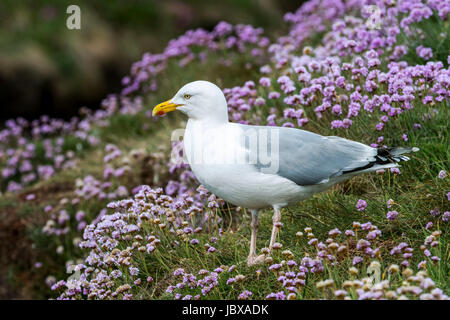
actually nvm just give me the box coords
[0,0,303,120]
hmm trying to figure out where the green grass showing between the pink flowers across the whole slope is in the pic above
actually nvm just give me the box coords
[0,5,450,299]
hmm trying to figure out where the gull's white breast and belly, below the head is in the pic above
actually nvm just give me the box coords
[184,122,309,209]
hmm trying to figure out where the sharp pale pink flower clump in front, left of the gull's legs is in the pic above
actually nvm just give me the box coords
[52,186,227,299]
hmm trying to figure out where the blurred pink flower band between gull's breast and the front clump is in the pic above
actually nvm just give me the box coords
[39,144,205,285]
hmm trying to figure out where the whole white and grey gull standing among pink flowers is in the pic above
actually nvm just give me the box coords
[153,81,419,265]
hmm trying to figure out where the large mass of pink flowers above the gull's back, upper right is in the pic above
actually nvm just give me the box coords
[217,1,450,143]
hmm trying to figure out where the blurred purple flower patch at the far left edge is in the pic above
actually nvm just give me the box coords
[0,116,98,192]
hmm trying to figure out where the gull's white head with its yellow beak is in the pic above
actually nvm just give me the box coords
[153,80,228,122]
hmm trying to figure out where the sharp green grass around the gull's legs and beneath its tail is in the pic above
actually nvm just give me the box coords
[135,95,449,299]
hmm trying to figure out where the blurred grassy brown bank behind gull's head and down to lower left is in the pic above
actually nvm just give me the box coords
[0,55,264,298]
